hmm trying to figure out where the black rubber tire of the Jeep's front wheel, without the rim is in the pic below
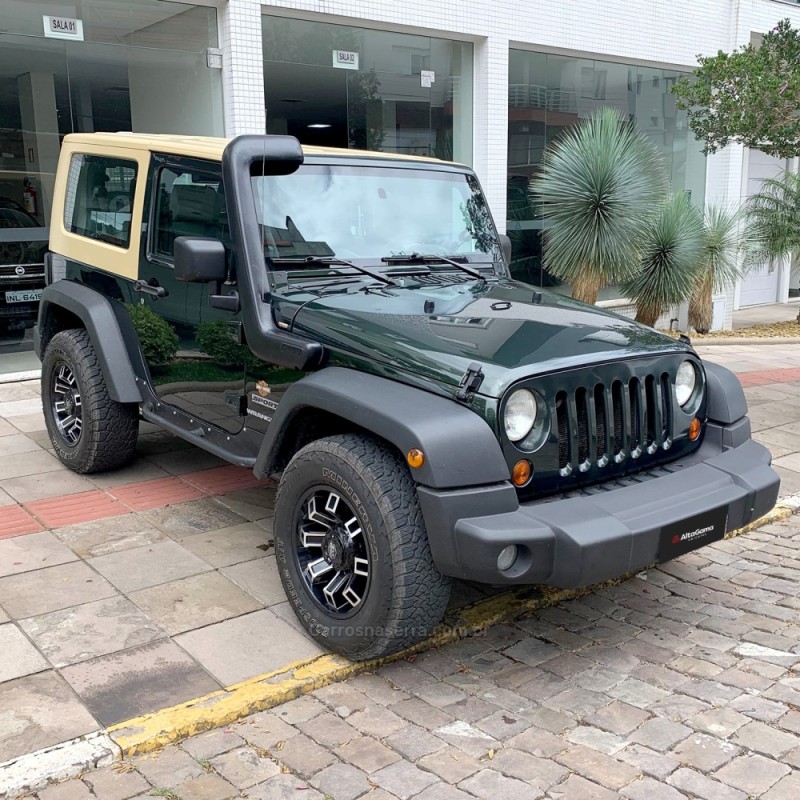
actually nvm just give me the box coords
[274,434,450,661]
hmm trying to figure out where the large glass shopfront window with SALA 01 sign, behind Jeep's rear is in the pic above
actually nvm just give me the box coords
[0,0,223,372]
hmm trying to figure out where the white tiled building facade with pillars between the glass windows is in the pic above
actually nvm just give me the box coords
[214,0,800,327]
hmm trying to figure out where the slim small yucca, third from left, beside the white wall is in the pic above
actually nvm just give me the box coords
[689,206,747,333]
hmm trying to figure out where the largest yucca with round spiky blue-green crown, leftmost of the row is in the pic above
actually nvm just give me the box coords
[531,108,667,303]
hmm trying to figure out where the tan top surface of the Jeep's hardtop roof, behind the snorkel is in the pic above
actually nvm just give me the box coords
[64,133,456,164]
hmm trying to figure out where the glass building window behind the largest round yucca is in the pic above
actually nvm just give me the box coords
[506,50,706,299]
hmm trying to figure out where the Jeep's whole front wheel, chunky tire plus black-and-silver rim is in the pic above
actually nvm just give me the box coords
[273,433,450,660]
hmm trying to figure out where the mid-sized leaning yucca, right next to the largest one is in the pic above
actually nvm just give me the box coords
[621,192,703,327]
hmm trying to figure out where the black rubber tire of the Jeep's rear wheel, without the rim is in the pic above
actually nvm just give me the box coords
[42,329,139,473]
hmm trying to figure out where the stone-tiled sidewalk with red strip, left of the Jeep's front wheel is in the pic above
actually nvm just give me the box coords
[0,382,334,763]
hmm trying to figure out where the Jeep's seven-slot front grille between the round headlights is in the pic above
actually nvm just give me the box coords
[554,372,673,477]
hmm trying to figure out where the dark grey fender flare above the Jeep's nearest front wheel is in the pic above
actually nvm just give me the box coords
[254,367,510,489]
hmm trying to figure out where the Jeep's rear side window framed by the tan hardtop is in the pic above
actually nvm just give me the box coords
[64,154,137,248]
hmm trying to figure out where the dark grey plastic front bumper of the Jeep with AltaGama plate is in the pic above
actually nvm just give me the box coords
[417,417,780,588]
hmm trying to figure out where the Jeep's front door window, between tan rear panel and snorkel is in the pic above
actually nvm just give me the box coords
[150,167,229,261]
